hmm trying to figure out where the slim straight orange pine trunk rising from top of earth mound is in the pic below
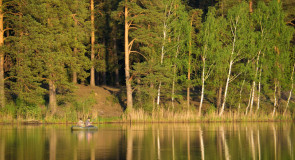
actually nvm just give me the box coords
[90,0,95,87]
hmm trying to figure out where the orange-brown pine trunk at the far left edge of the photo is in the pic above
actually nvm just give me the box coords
[0,0,5,108]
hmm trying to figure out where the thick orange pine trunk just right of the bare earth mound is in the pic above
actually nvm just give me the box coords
[124,4,133,110]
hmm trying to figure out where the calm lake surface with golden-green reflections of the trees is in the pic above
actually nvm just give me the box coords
[0,122,295,160]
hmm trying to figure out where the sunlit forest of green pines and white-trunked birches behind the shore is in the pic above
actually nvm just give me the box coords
[0,0,295,121]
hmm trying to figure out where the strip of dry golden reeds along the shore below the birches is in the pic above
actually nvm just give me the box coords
[122,109,292,122]
